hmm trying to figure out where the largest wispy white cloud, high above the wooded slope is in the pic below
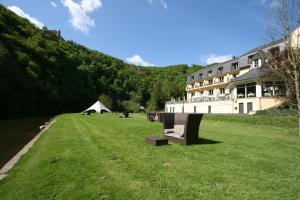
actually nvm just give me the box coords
[61,0,102,33]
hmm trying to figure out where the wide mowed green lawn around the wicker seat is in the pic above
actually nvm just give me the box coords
[0,114,300,200]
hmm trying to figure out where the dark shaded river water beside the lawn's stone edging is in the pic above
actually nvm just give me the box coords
[0,117,50,168]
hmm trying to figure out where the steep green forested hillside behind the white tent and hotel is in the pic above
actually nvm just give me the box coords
[0,5,201,118]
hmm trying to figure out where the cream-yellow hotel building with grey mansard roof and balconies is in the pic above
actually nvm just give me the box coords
[165,28,300,114]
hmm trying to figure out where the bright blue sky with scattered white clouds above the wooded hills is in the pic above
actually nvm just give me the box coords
[0,0,276,66]
